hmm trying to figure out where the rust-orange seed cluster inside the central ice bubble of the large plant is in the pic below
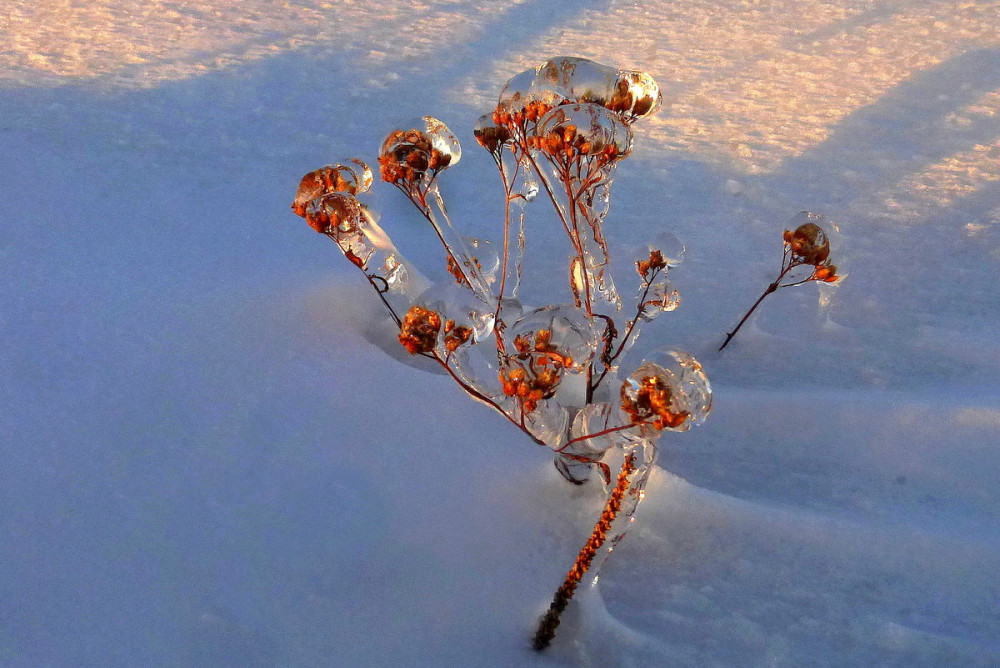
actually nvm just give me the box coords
[500,329,573,413]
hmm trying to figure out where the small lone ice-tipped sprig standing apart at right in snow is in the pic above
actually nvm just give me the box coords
[719,211,843,350]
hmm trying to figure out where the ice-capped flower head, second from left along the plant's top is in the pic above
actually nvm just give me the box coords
[378,116,462,185]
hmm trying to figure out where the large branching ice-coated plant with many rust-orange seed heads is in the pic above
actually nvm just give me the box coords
[292,57,712,649]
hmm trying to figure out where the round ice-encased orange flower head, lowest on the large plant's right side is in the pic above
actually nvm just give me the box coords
[621,351,712,438]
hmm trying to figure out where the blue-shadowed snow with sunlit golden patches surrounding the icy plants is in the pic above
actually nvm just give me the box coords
[0,0,1000,668]
